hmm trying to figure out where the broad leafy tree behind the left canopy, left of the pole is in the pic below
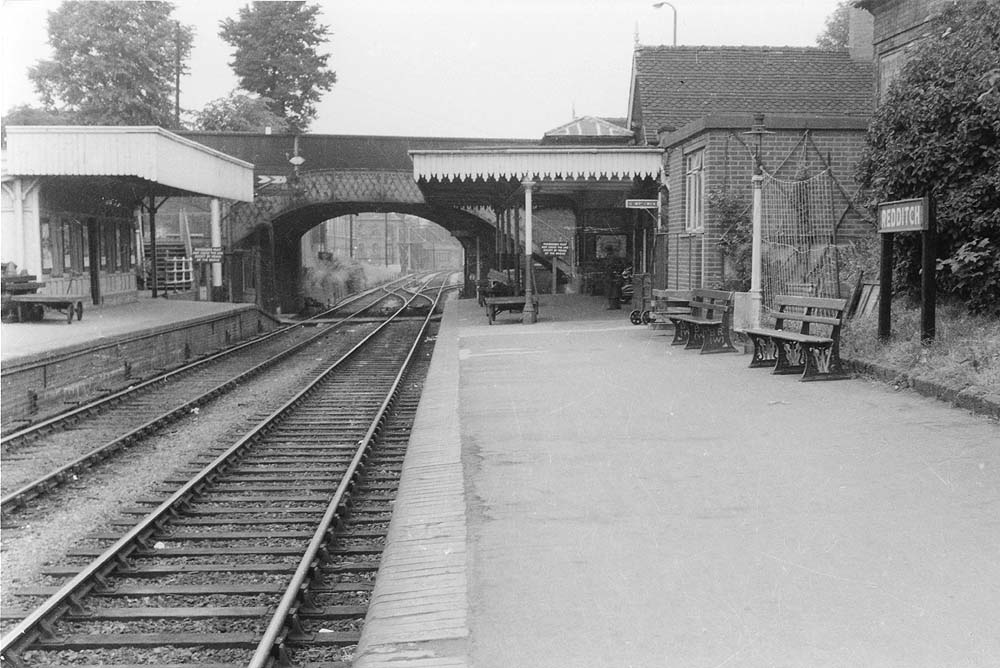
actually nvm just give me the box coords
[28,1,192,127]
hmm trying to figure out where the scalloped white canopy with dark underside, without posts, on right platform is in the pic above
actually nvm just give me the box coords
[410,146,663,205]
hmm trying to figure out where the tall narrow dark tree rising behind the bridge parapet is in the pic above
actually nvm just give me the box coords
[219,2,337,132]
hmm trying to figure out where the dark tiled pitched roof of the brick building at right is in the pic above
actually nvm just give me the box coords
[629,46,874,144]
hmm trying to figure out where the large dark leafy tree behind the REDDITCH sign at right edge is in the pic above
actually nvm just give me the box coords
[859,0,1000,314]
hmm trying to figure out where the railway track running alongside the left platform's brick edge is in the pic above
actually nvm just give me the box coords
[0,277,446,516]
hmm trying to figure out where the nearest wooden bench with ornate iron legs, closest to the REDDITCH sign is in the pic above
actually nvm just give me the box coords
[746,295,848,380]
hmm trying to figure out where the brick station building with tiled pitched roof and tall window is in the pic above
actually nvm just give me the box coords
[628,42,873,290]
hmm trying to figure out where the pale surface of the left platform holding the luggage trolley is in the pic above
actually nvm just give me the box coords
[0,297,255,362]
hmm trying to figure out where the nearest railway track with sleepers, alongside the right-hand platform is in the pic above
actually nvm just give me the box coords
[0,280,448,666]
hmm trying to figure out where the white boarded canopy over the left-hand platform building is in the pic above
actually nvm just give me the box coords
[4,125,254,202]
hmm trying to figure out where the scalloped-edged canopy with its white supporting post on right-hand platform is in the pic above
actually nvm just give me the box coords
[410,146,663,323]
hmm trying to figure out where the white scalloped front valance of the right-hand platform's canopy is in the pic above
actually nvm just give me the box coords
[410,146,663,181]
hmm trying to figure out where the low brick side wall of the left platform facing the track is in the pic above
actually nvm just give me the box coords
[0,306,276,428]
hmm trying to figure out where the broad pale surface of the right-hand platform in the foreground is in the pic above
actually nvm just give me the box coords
[355,295,1000,668]
